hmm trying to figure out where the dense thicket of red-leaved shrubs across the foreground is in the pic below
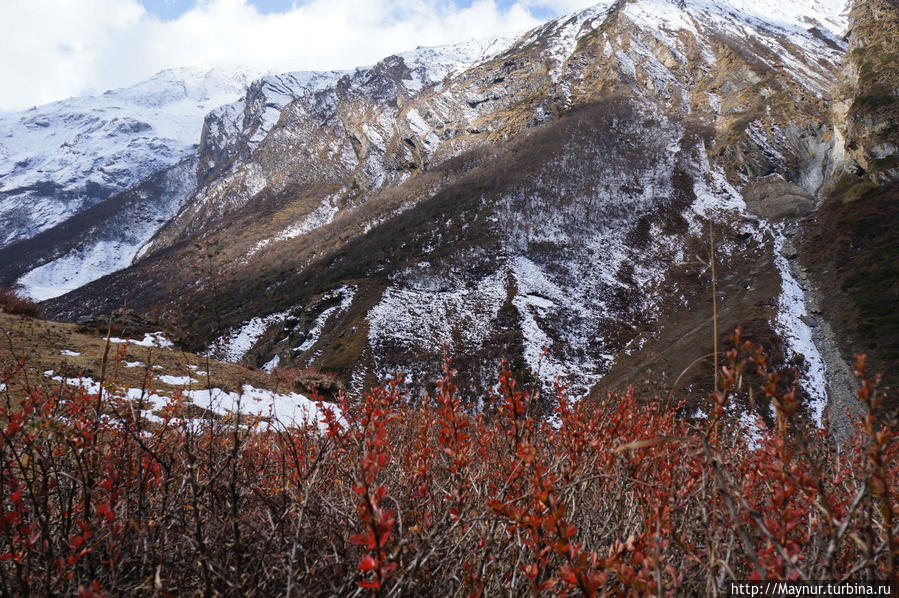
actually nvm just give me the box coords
[0,330,899,596]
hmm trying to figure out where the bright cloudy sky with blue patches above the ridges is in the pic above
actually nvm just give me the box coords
[0,0,595,112]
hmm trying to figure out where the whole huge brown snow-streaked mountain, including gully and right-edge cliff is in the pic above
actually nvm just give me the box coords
[0,0,896,440]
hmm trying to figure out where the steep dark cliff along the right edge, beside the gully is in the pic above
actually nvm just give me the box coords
[799,0,899,422]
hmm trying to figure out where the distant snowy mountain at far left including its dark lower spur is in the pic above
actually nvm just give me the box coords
[0,68,248,299]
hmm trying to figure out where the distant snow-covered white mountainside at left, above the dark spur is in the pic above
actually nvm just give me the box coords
[0,68,248,247]
